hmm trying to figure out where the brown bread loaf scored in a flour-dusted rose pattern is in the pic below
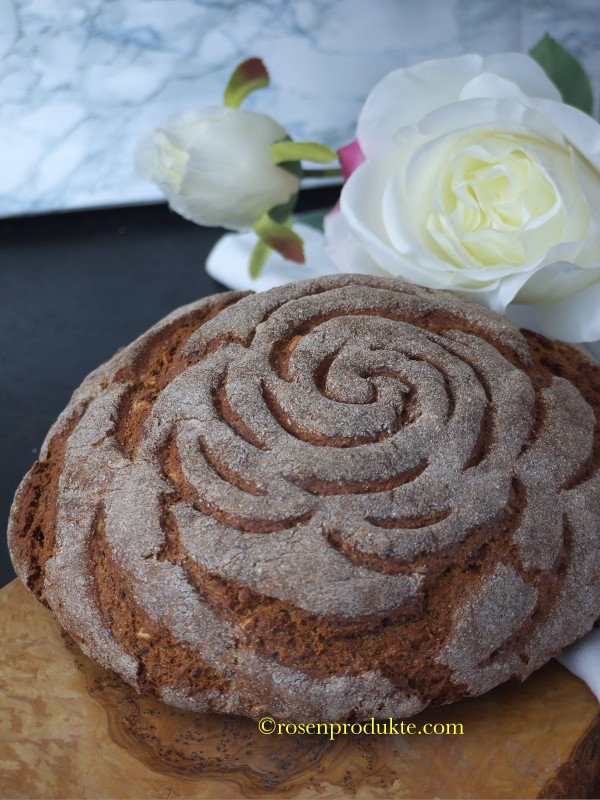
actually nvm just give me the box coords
[10,275,600,722]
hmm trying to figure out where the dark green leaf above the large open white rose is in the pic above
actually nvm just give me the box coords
[529,34,594,114]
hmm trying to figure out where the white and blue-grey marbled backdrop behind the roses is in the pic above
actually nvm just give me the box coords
[0,0,600,217]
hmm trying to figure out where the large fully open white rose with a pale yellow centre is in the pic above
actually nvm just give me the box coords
[326,53,600,341]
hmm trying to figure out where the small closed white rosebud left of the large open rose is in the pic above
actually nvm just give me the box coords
[136,106,300,230]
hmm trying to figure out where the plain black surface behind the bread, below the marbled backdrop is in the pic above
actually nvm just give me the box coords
[0,187,339,587]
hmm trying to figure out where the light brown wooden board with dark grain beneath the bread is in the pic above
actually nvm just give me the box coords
[0,581,600,798]
